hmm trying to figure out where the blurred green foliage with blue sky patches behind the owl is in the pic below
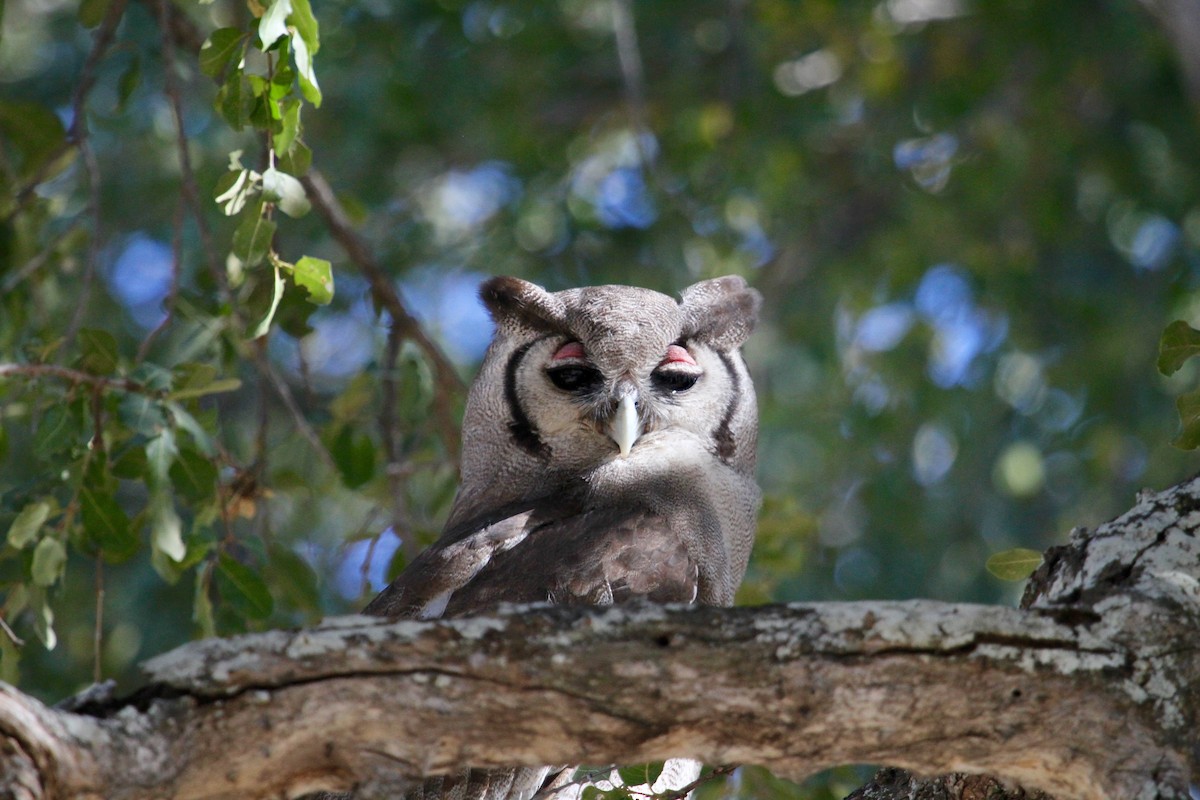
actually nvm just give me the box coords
[0,0,1200,796]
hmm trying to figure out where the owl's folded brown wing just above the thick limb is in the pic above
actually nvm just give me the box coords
[365,498,700,619]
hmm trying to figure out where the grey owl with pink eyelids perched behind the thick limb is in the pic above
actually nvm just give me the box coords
[365,276,761,800]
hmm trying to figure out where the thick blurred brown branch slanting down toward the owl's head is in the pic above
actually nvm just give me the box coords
[300,169,466,470]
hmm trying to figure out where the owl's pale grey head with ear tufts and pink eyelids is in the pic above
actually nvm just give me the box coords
[450,276,761,532]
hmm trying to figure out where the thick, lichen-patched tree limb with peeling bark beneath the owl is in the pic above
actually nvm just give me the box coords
[0,481,1200,800]
